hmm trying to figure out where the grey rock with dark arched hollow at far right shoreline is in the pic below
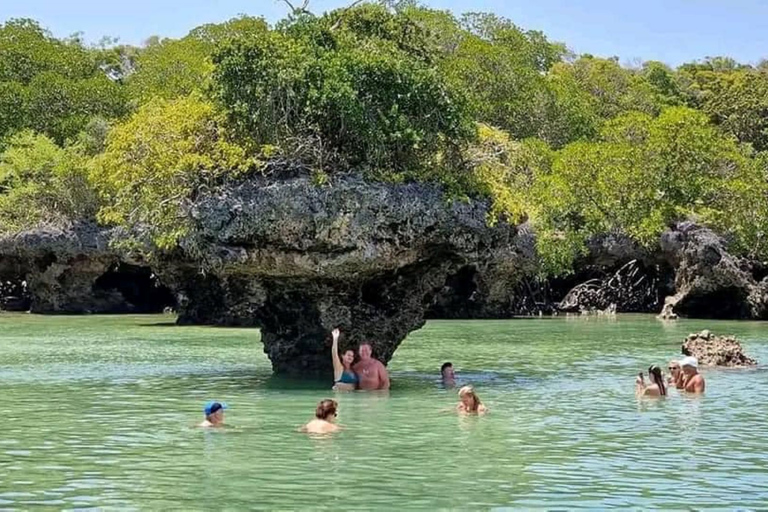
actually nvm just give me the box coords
[661,222,768,319]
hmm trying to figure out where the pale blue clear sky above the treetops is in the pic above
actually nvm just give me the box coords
[0,0,768,66]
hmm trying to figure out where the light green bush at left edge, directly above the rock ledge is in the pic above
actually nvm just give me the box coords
[0,131,98,233]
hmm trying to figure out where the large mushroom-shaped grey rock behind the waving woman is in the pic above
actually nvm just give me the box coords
[158,176,519,374]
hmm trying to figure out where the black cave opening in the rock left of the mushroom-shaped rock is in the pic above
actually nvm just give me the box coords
[93,262,176,313]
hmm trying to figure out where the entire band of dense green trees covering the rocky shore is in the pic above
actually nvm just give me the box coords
[0,0,768,273]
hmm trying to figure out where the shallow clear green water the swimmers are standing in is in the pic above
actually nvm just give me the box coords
[0,314,768,510]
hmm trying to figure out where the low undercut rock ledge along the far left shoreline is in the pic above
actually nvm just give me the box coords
[0,223,173,313]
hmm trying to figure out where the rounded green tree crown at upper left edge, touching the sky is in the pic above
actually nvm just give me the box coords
[0,20,126,144]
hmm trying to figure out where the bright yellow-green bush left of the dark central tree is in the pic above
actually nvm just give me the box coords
[92,95,251,248]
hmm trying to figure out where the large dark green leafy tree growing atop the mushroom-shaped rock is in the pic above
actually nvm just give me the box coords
[214,5,474,171]
